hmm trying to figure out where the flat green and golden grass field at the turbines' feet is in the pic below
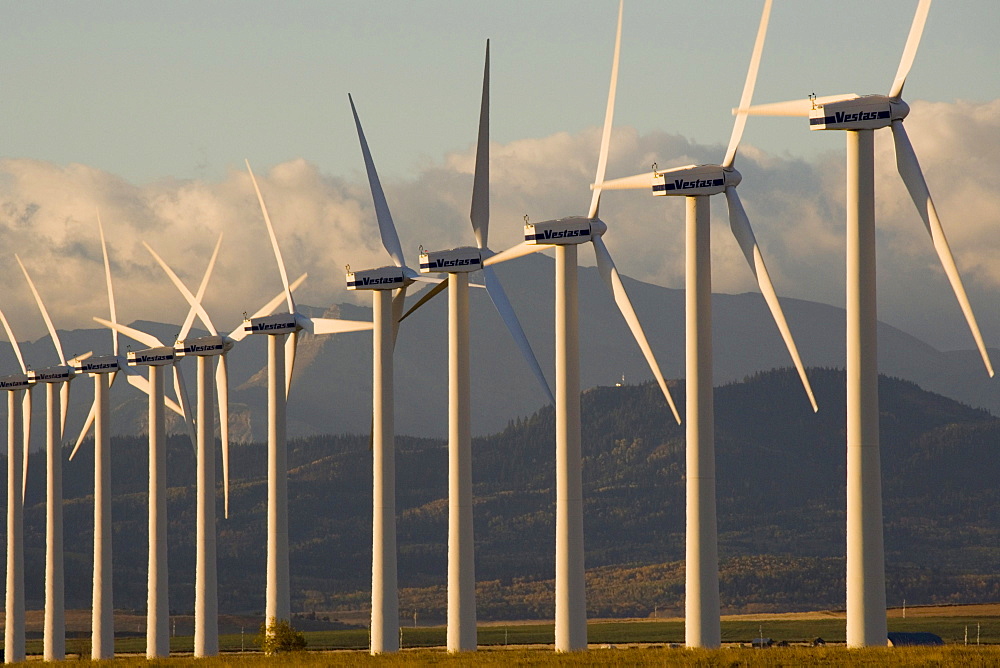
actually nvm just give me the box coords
[9,605,1000,666]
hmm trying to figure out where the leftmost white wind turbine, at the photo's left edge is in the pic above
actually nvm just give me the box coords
[0,310,30,663]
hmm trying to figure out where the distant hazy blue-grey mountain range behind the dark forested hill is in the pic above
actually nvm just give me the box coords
[0,254,1000,444]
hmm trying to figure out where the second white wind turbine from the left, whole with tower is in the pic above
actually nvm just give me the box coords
[14,255,90,661]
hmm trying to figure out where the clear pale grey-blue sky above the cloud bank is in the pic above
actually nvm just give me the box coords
[7,0,1000,183]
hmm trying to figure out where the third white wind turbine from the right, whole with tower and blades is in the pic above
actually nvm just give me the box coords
[483,4,680,652]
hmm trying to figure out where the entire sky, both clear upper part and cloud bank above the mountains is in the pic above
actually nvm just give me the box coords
[0,0,1000,363]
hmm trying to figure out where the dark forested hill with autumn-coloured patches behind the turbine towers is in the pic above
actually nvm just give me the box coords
[3,369,1000,619]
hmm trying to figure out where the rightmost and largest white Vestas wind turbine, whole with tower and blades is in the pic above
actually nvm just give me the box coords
[741,0,993,647]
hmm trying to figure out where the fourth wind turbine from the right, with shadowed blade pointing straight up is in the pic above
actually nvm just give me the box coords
[411,41,555,652]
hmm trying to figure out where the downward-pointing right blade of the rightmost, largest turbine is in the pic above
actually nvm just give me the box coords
[892,121,993,378]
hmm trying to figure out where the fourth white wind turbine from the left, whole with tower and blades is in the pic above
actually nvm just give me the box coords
[94,278,204,658]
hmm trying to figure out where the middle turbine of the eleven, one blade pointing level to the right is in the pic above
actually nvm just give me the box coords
[243,161,373,624]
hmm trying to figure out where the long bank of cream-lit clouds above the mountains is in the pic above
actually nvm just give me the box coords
[0,100,1000,352]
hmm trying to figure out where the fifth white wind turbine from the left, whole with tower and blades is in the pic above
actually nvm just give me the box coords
[143,234,305,657]
